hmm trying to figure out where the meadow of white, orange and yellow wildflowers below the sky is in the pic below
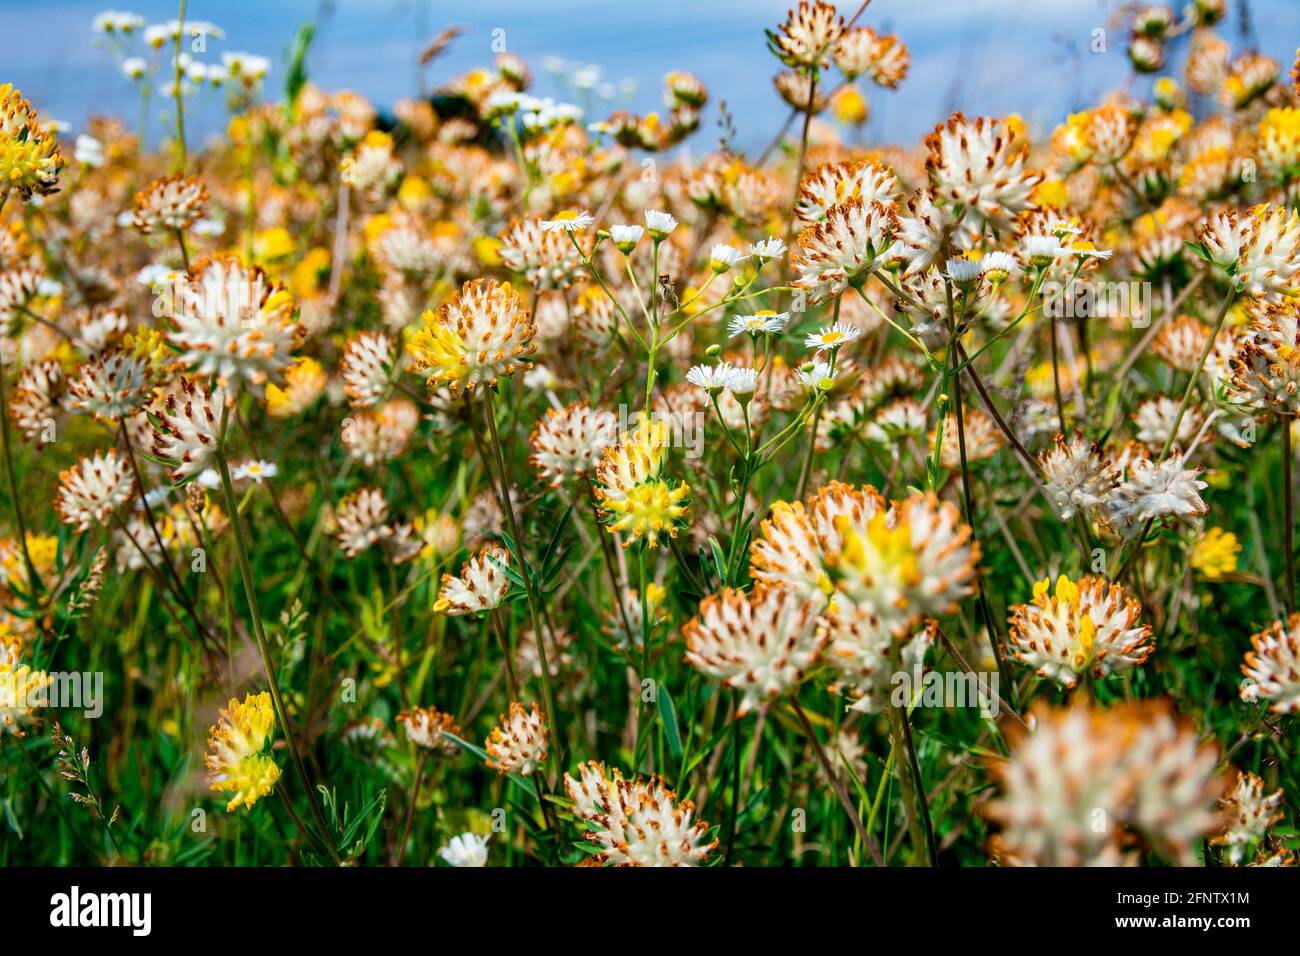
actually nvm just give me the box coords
[0,0,1300,894]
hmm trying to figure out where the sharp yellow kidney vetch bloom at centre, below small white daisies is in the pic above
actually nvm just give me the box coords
[595,416,690,548]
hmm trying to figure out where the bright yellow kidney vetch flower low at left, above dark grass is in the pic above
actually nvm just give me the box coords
[207,691,280,813]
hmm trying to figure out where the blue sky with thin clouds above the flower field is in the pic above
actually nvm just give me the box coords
[0,0,1300,146]
